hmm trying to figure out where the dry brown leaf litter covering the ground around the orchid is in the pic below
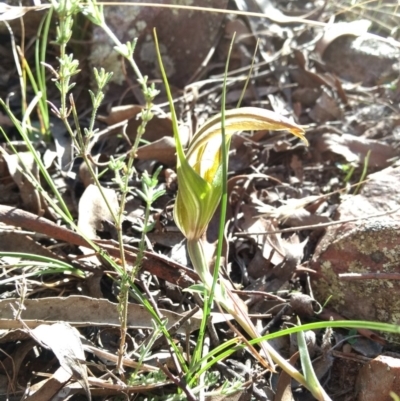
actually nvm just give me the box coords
[0,1,400,401]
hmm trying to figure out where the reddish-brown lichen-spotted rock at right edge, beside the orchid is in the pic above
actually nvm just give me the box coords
[310,167,400,338]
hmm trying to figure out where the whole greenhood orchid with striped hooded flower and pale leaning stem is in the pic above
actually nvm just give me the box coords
[155,29,330,401]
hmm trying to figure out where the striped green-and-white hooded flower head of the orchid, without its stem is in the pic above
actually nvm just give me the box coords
[174,107,307,240]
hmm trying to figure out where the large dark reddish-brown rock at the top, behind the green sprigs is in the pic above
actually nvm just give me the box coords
[89,0,228,87]
